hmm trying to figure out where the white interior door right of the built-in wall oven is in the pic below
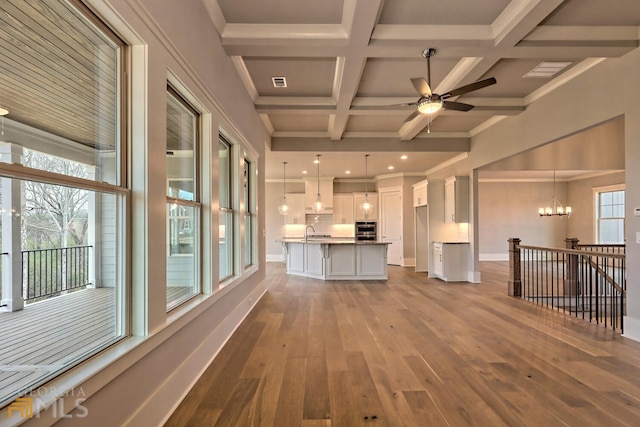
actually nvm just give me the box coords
[378,189,404,265]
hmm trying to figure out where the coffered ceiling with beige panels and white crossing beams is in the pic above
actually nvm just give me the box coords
[203,0,640,178]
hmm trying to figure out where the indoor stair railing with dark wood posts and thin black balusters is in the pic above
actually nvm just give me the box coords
[509,238,626,332]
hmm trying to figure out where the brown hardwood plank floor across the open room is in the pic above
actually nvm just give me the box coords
[166,263,640,427]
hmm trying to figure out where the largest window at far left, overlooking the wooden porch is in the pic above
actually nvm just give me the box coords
[0,0,129,405]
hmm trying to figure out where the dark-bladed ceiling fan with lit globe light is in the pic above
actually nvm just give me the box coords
[399,48,496,123]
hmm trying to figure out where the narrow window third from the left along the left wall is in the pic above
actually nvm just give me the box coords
[218,136,234,281]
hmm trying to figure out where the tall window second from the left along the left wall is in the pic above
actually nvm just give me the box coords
[166,87,201,310]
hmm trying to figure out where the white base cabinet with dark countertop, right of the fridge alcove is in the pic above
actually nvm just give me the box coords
[429,242,469,282]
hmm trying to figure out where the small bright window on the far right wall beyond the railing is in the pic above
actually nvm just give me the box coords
[594,186,625,244]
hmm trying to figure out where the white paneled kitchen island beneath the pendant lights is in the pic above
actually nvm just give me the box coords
[280,238,389,280]
